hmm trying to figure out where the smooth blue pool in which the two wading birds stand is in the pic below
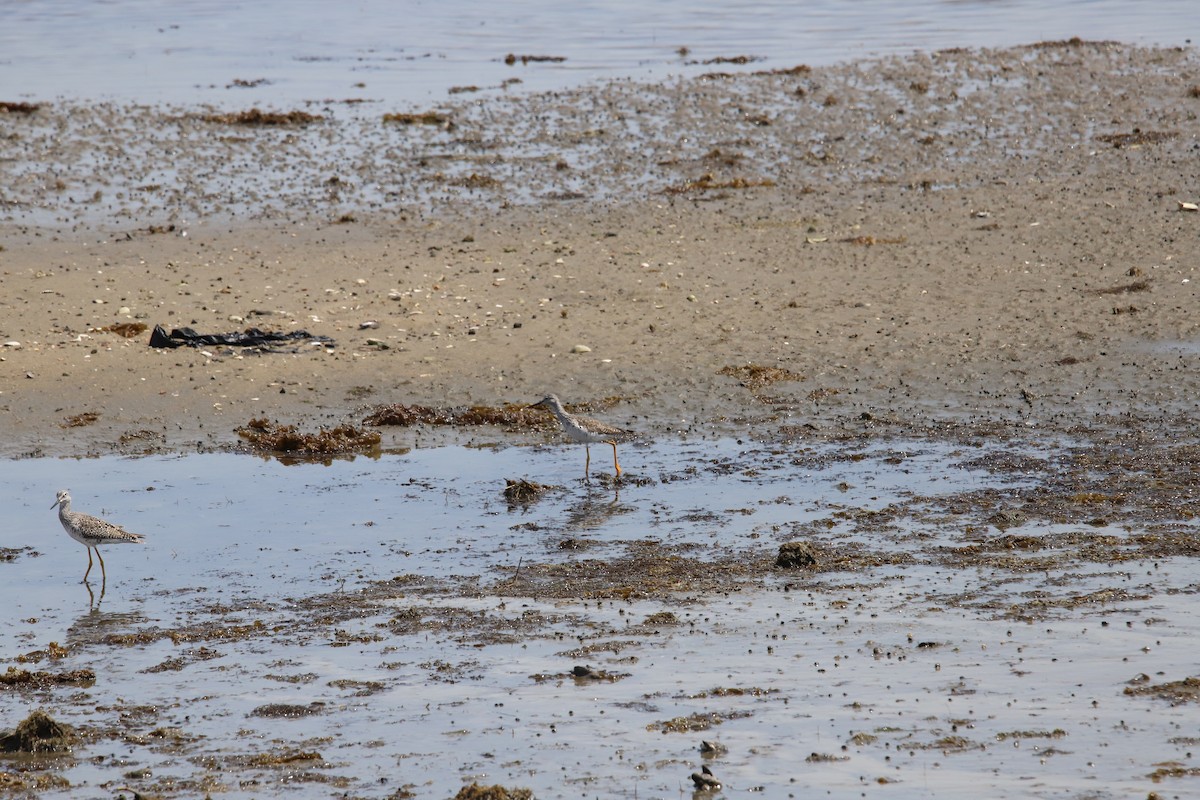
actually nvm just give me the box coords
[0,440,974,610]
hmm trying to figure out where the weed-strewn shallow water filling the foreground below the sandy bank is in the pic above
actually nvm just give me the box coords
[0,439,1200,798]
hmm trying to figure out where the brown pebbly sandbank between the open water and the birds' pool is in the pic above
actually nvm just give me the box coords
[0,41,1200,457]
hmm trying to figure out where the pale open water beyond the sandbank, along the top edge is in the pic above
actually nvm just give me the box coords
[0,0,1200,107]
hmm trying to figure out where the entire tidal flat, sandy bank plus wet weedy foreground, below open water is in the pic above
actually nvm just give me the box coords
[0,41,1200,798]
